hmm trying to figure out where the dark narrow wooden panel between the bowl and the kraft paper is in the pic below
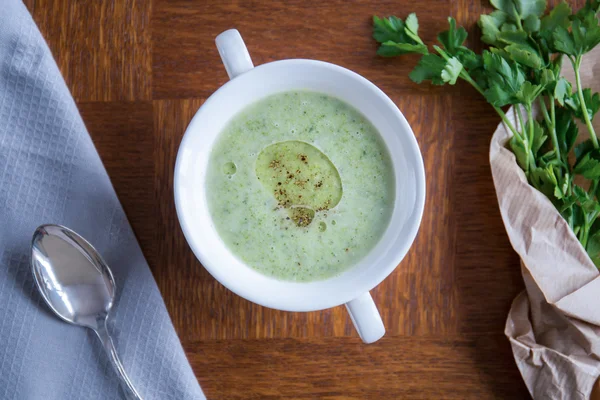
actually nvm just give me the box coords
[452,98,524,333]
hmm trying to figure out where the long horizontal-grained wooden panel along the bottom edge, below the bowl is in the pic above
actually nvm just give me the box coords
[188,335,529,400]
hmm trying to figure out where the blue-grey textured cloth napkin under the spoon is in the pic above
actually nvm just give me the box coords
[0,0,204,400]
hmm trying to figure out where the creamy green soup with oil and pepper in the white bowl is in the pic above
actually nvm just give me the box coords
[206,91,395,282]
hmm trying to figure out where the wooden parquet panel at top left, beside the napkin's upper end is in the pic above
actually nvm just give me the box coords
[27,0,152,101]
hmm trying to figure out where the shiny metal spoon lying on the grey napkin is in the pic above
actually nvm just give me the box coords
[31,225,141,400]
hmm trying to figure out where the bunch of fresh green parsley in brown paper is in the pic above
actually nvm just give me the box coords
[373,0,600,266]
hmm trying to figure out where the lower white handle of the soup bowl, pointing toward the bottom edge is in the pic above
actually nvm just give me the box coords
[346,292,385,343]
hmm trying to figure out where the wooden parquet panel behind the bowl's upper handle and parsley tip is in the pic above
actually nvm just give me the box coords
[152,0,460,99]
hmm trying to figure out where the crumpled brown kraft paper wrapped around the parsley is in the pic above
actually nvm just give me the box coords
[490,47,600,399]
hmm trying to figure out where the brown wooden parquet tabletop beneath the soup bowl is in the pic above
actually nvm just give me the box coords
[26,0,552,399]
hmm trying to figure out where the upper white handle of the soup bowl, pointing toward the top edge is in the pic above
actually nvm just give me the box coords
[215,29,254,79]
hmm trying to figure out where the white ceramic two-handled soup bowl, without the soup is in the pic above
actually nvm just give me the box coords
[174,29,425,343]
